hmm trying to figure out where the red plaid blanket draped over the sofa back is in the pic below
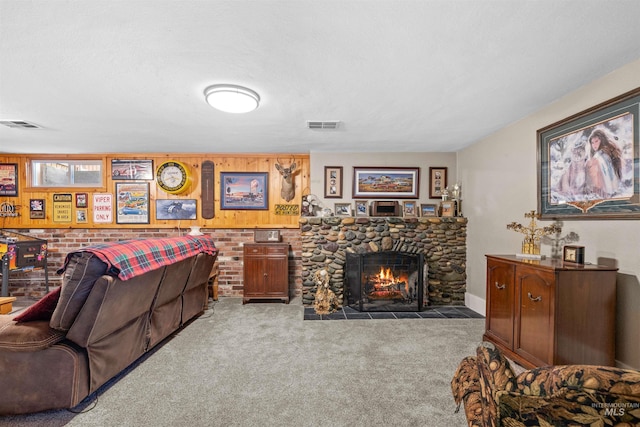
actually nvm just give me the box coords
[57,236,218,280]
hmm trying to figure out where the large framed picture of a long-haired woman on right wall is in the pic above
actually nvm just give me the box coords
[537,88,640,220]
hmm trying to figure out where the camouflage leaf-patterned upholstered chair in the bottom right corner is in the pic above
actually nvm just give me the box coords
[451,342,640,427]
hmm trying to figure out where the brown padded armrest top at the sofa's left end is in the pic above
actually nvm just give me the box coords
[0,316,64,351]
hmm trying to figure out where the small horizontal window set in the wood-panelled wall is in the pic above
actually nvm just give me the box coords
[30,160,103,187]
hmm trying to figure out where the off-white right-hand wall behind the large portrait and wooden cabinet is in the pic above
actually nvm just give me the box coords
[458,60,640,369]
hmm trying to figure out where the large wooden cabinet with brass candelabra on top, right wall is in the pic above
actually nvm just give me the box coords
[483,255,617,368]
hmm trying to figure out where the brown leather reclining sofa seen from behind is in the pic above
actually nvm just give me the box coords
[0,237,217,415]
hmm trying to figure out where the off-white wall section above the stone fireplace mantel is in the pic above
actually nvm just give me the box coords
[302,152,456,214]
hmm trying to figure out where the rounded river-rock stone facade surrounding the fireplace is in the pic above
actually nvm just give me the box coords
[300,216,467,306]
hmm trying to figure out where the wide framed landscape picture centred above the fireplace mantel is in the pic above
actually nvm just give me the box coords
[353,167,420,199]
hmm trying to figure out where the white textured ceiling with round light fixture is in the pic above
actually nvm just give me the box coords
[0,0,640,153]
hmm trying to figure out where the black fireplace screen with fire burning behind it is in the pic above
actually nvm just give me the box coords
[345,251,424,311]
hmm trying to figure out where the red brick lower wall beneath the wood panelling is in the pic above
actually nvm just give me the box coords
[3,228,302,298]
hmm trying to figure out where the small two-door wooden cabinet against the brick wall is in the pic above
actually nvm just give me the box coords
[242,243,289,304]
